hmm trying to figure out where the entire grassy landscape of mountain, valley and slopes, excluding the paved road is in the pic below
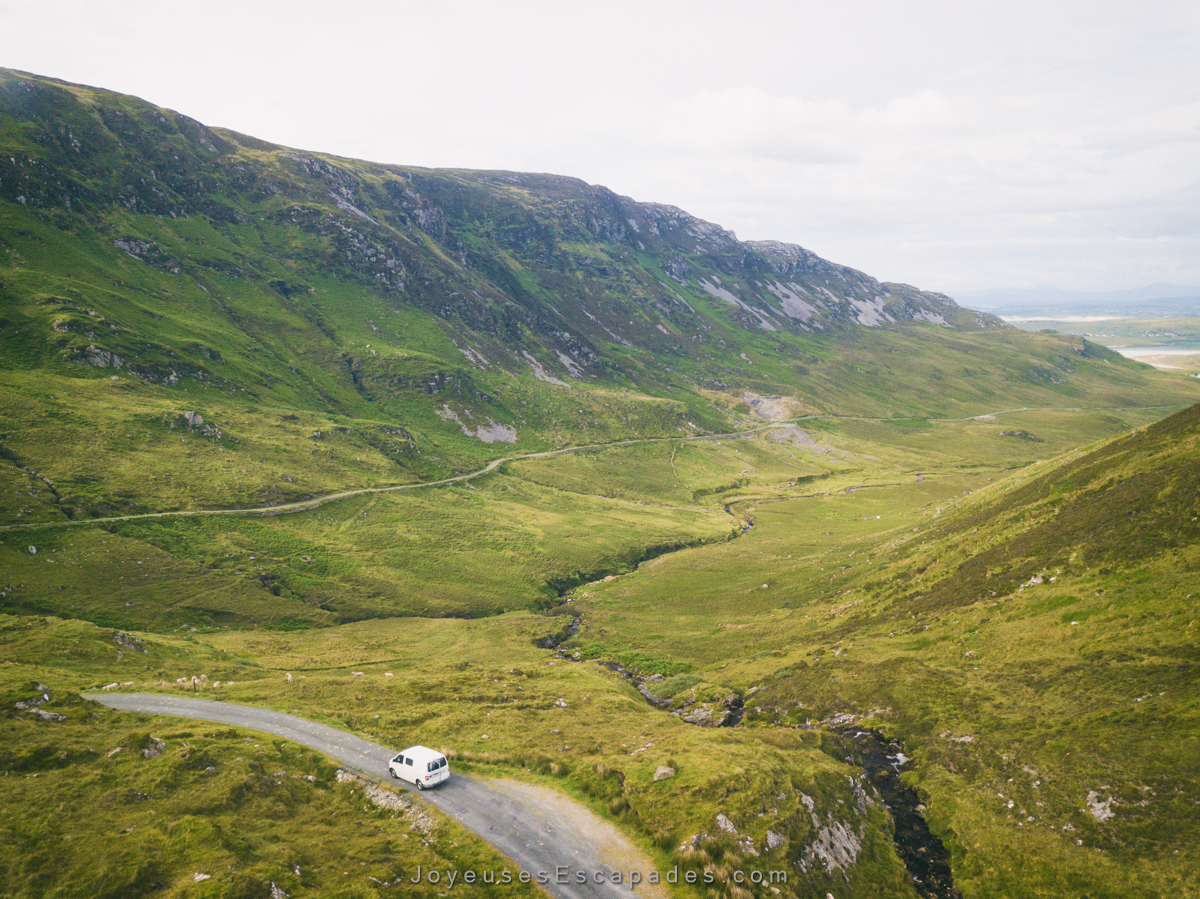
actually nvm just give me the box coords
[0,64,1200,899]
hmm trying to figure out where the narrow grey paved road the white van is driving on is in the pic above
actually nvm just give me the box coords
[85,693,665,899]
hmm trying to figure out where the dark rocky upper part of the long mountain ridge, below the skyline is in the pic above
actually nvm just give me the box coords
[0,72,1001,393]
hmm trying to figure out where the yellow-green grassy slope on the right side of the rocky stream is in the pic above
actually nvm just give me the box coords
[568,407,1200,897]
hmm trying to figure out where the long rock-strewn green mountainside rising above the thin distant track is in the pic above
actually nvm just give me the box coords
[0,71,1198,521]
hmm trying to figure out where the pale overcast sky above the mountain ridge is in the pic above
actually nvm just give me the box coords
[0,0,1200,294]
